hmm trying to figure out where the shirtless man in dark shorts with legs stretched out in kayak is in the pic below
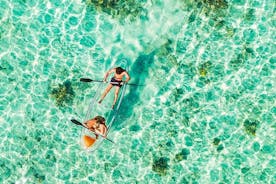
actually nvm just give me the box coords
[99,67,130,109]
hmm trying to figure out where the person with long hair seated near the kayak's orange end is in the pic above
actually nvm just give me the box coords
[84,116,107,139]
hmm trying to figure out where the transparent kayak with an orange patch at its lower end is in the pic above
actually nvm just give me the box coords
[80,60,128,152]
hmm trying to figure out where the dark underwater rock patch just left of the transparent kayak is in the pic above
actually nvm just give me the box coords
[51,81,75,106]
